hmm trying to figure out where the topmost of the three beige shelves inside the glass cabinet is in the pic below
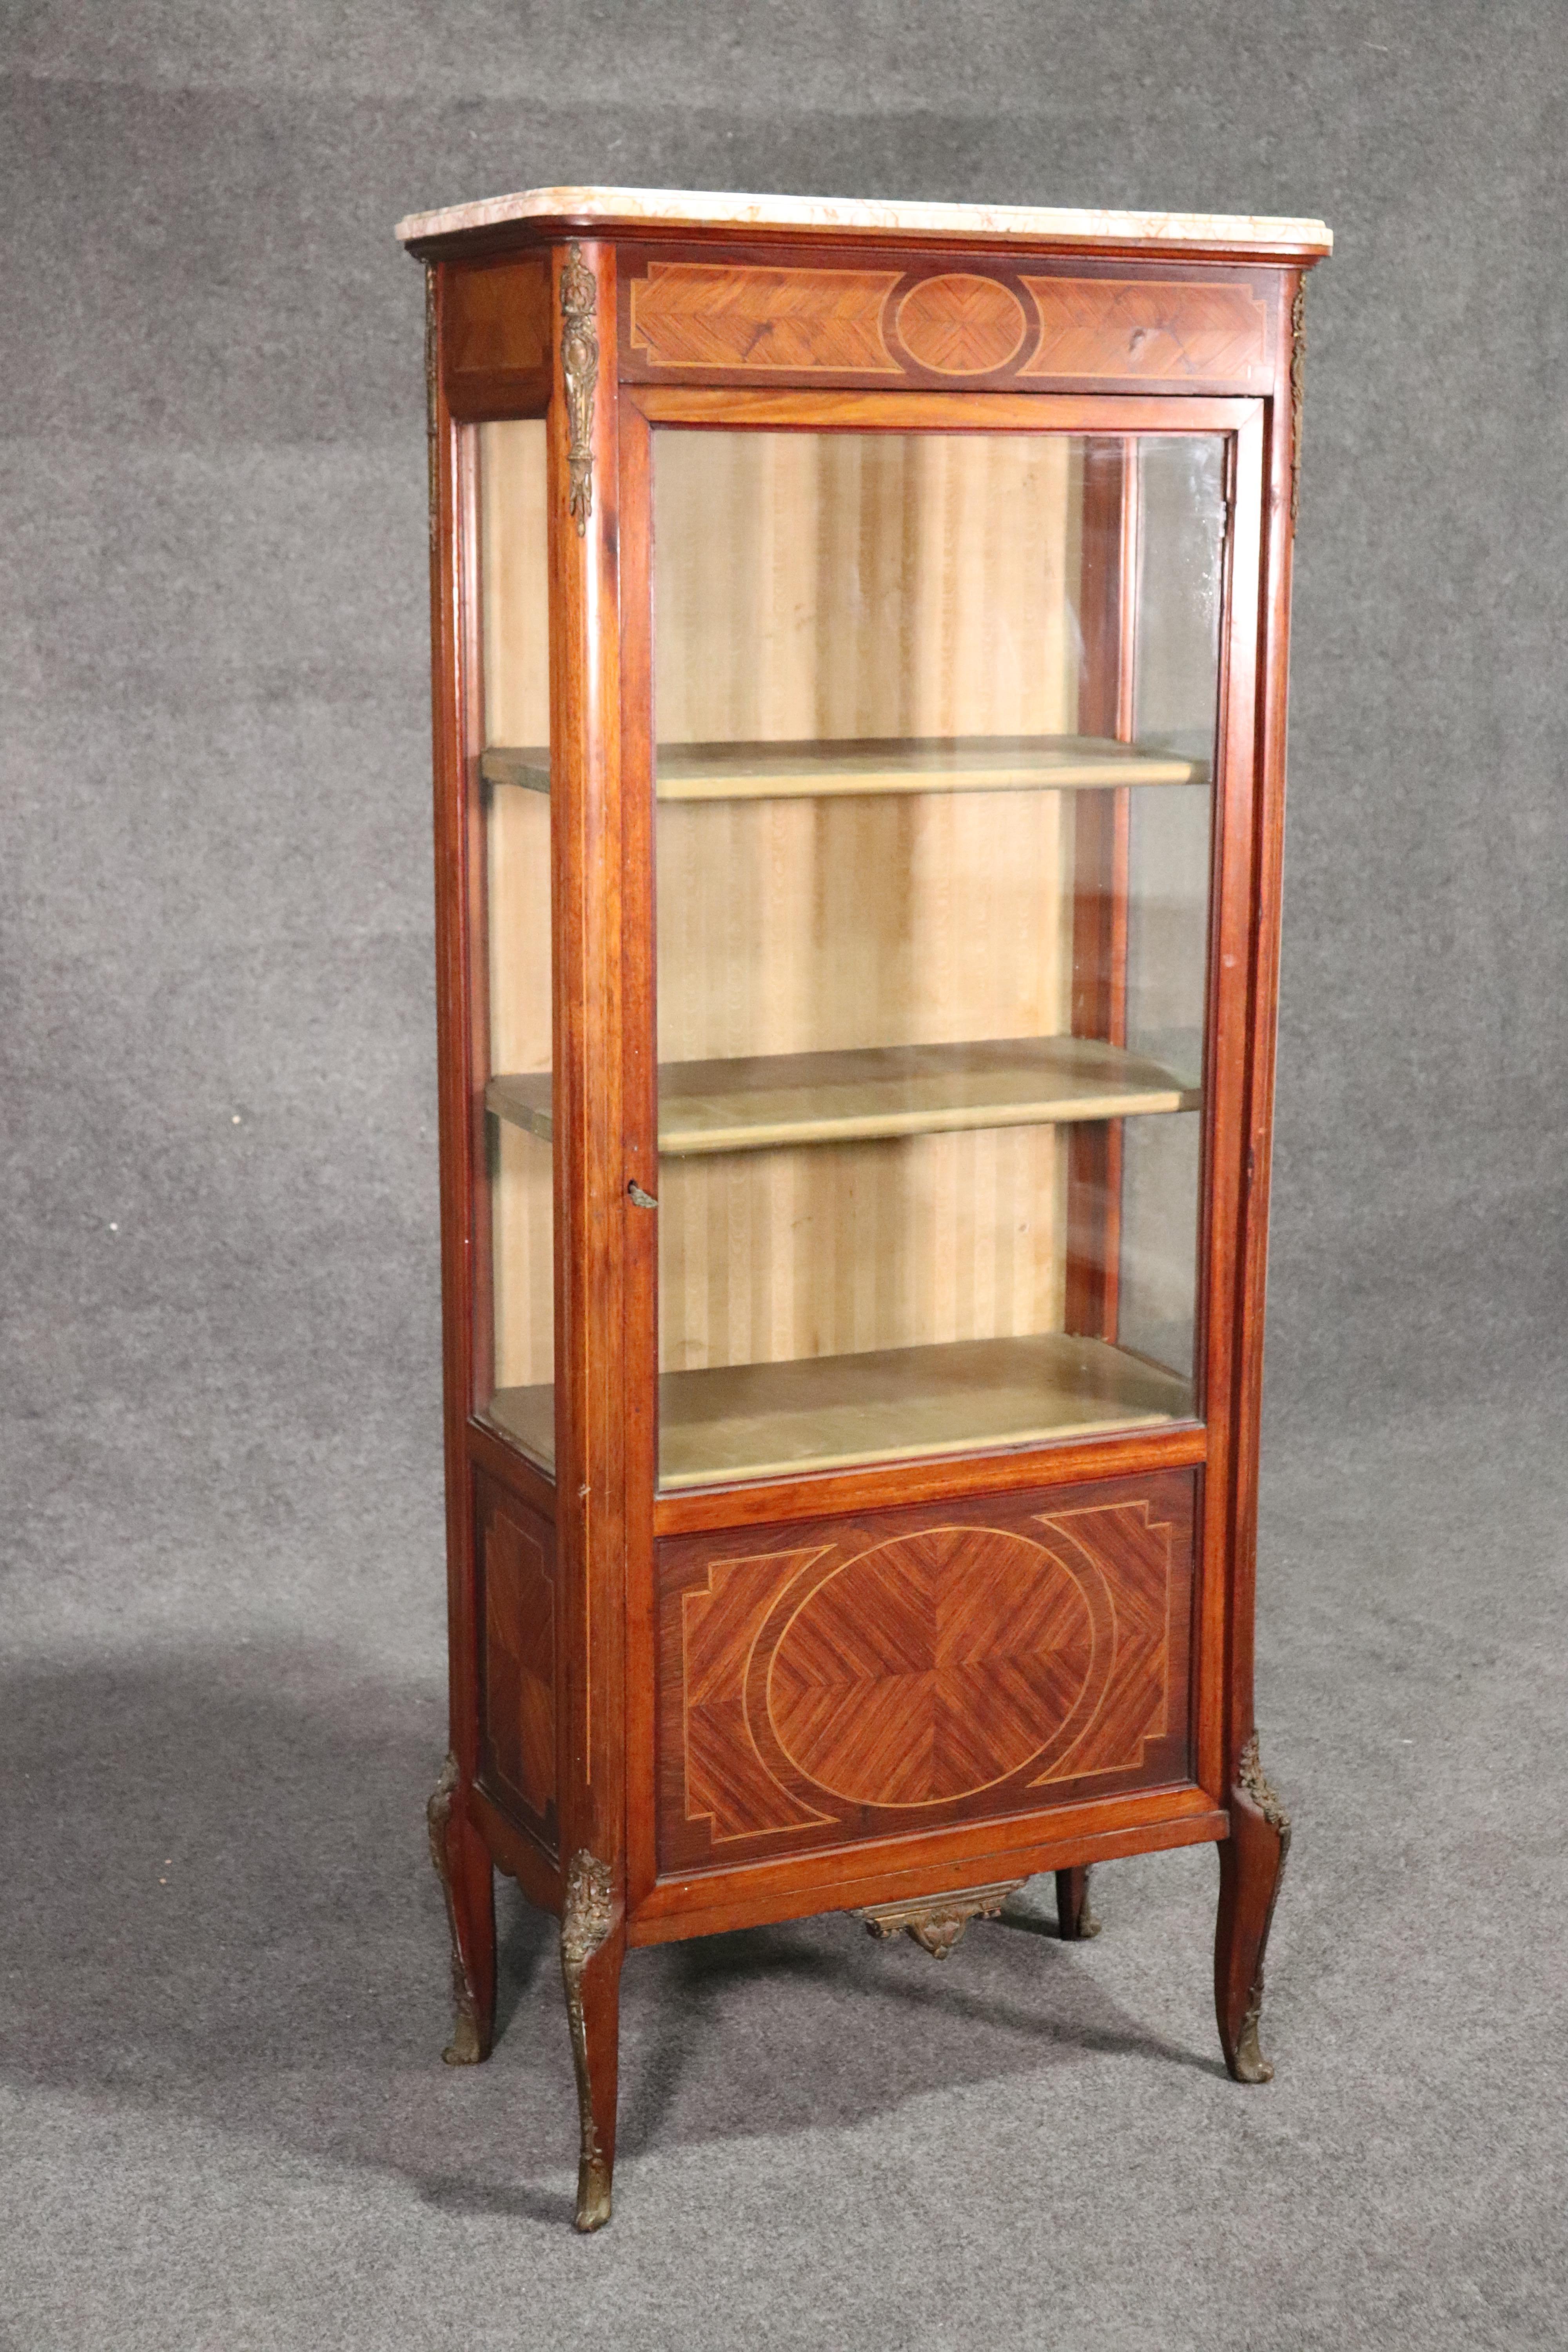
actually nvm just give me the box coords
[479,736,1208,800]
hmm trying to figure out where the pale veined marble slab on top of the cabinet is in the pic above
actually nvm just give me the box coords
[397,188,1333,254]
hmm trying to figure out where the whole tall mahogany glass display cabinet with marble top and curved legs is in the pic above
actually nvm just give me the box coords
[399,188,1328,2230]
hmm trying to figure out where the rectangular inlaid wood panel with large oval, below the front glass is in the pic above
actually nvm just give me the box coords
[658,1472,1194,1870]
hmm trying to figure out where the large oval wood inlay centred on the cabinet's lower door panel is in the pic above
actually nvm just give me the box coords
[769,1526,1093,1804]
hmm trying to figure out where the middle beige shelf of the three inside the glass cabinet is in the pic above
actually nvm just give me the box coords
[484,1037,1201,1155]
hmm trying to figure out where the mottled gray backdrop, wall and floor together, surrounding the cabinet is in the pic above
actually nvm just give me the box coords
[0,0,1568,2352]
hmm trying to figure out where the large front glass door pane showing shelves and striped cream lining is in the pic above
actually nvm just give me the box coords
[653,428,1222,1486]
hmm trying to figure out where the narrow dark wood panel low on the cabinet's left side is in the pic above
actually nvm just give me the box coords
[475,1472,557,1853]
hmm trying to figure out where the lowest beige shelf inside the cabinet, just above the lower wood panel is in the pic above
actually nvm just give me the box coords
[484,1331,1192,1486]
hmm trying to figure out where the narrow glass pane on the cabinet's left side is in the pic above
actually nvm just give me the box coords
[477,421,555,1470]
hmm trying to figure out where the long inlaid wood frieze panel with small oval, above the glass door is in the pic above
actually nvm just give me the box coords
[621,254,1269,390]
